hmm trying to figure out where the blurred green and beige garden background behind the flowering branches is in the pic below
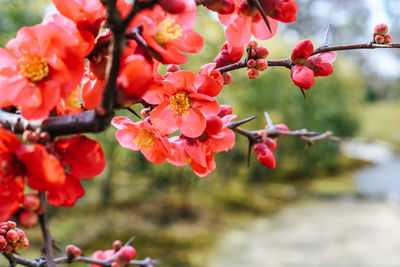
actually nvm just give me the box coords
[0,0,400,267]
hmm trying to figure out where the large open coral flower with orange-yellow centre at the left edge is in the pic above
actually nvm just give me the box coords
[0,15,87,119]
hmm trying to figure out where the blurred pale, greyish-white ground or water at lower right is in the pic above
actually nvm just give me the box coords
[208,142,400,267]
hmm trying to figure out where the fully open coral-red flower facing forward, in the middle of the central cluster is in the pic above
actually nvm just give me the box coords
[143,71,219,138]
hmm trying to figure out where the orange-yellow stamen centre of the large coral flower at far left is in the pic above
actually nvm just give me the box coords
[18,55,50,83]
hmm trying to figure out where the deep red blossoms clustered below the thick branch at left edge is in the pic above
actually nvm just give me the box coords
[0,128,105,221]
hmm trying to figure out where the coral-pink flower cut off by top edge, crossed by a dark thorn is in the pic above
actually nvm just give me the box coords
[218,0,278,46]
